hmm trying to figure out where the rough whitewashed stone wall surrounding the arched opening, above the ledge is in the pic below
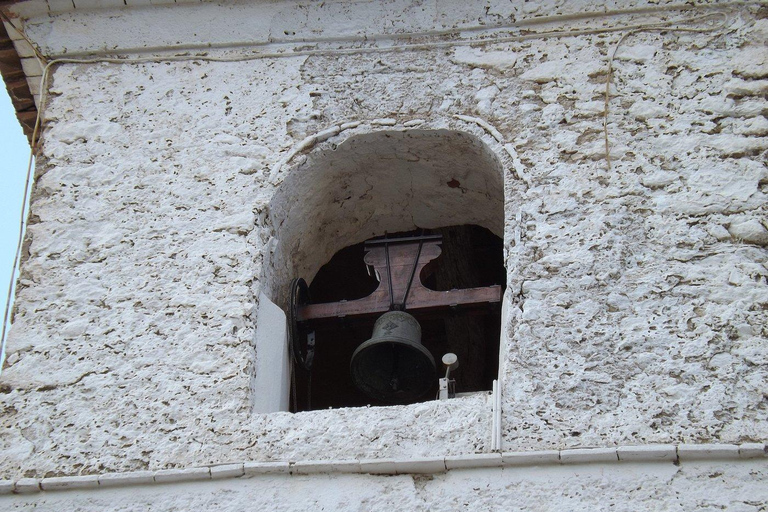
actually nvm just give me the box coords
[0,3,768,482]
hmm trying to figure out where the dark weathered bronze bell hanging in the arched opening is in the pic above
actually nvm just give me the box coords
[350,311,436,404]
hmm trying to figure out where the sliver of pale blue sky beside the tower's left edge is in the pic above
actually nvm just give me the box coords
[0,85,29,352]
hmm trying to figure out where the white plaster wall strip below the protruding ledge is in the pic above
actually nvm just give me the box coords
[0,462,768,512]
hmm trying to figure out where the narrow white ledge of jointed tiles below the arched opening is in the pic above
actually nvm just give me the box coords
[0,443,768,495]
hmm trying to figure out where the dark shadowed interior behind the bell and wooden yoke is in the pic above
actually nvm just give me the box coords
[292,225,506,410]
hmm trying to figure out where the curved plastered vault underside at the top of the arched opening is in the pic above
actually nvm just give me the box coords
[262,129,516,305]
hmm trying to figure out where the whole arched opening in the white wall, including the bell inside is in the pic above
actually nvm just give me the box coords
[260,129,506,411]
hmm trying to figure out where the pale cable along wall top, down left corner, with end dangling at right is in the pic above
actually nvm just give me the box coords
[0,1,736,373]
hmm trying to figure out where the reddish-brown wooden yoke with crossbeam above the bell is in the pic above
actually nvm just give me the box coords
[296,235,502,322]
